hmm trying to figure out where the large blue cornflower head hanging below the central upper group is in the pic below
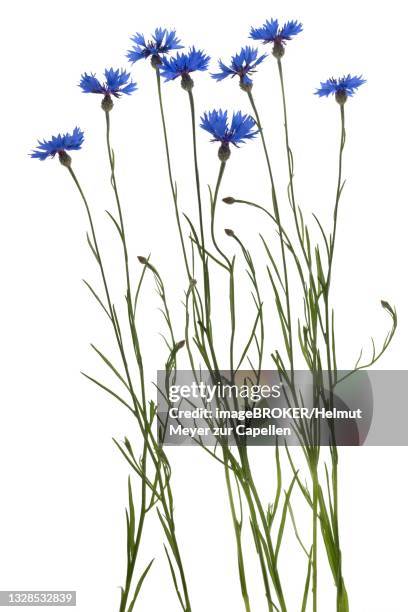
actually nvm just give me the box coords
[200,109,258,161]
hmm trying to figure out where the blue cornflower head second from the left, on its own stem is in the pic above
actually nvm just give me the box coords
[79,68,137,111]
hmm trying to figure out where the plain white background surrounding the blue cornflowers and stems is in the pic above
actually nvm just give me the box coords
[0,0,408,612]
